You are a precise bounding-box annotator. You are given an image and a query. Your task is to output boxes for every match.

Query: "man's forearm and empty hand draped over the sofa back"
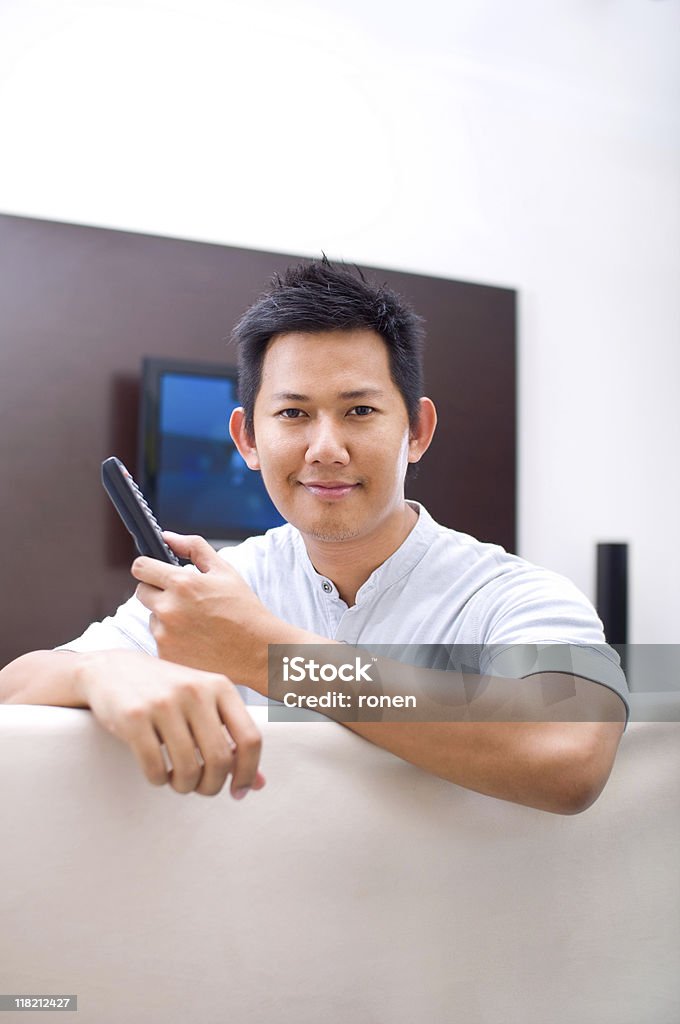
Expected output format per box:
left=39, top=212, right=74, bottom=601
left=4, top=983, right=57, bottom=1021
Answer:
left=0, top=650, right=264, bottom=799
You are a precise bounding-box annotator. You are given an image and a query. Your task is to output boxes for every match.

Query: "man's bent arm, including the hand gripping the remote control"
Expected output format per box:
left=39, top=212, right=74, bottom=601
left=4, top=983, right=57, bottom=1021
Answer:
left=132, top=536, right=625, bottom=814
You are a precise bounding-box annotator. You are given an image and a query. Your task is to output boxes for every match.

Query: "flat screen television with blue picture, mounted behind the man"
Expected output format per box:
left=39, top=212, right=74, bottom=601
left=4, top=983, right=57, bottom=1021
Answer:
left=137, top=357, right=284, bottom=545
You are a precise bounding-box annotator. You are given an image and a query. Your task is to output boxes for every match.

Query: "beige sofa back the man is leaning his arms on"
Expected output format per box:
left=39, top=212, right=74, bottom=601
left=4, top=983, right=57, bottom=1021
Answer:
left=0, top=694, right=680, bottom=1024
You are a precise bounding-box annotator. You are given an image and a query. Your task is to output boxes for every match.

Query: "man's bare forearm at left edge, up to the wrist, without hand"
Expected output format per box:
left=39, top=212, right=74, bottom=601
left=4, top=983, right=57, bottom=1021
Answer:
left=0, top=650, right=88, bottom=708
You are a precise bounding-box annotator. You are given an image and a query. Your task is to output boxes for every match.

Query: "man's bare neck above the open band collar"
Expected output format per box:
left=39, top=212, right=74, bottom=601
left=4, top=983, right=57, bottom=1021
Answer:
left=302, top=502, right=418, bottom=607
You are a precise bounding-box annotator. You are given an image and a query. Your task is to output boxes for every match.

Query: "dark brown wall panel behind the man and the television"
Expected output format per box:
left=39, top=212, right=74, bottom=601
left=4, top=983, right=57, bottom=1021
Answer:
left=0, top=216, right=515, bottom=665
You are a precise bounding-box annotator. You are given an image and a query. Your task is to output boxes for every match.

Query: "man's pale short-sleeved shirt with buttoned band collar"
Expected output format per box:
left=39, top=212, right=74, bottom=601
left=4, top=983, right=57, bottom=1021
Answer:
left=59, top=502, right=629, bottom=720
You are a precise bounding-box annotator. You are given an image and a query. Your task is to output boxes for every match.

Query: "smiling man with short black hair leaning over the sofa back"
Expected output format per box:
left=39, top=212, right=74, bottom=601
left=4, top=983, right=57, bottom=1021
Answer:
left=0, top=259, right=626, bottom=813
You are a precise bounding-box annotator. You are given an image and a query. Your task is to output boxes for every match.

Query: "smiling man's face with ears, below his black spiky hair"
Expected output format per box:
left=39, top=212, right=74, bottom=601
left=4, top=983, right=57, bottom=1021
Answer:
left=235, top=330, right=424, bottom=542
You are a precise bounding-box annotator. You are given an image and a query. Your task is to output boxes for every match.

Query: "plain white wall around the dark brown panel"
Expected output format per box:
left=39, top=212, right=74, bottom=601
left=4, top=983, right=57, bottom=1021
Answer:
left=0, top=0, right=680, bottom=643
